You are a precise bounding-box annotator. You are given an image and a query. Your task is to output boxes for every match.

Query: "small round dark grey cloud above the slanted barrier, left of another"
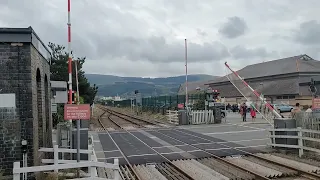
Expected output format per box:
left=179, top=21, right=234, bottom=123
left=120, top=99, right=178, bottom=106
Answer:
left=219, top=16, right=248, bottom=39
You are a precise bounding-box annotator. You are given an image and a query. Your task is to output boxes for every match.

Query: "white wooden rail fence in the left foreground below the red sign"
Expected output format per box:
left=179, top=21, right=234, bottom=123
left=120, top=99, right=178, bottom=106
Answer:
left=13, top=145, right=120, bottom=180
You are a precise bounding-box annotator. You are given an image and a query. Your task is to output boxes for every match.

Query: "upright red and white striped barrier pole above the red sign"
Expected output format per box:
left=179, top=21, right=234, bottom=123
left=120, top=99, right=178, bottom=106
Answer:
left=68, top=0, right=72, bottom=104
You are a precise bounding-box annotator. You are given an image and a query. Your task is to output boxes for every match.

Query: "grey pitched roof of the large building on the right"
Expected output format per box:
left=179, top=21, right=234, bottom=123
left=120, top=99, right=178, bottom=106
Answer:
left=209, top=54, right=320, bottom=84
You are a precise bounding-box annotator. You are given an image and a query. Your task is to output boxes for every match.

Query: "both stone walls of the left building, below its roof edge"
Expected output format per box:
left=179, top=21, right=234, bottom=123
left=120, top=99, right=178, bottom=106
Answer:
left=0, top=43, right=52, bottom=175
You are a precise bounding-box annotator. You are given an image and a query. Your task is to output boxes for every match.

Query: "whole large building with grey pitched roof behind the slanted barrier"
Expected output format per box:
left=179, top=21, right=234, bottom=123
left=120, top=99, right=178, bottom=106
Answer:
left=207, top=54, right=320, bottom=105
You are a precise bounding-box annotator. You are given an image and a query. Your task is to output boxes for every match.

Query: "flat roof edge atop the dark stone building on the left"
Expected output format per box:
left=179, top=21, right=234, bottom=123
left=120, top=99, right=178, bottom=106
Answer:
left=0, top=26, right=51, bottom=61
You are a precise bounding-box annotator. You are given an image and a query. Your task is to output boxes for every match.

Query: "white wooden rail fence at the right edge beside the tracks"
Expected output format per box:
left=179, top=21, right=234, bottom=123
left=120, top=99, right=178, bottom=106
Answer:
left=268, top=127, right=320, bottom=157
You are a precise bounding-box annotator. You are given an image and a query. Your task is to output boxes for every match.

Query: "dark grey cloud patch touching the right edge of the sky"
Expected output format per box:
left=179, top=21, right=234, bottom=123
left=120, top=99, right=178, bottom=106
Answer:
left=294, top=20, right=320, bottom=45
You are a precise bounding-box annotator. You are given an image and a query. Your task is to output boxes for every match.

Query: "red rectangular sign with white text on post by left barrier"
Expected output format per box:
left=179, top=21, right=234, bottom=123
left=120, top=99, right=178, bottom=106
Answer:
left=64, top=104, right=90, bottom=120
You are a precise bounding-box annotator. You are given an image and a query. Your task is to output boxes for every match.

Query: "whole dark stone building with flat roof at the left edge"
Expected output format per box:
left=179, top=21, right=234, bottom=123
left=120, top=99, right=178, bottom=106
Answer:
left=0, top=27, right=52, bottom=175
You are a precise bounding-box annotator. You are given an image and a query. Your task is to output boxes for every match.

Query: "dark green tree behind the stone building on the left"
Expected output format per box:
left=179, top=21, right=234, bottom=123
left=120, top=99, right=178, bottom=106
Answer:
left=48, top=42, right=98, bottom=104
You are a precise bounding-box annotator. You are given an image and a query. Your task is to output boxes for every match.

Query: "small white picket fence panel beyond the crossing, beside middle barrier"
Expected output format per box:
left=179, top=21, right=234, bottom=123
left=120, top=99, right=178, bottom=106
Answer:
left=191, top=110, right=214, bottom=124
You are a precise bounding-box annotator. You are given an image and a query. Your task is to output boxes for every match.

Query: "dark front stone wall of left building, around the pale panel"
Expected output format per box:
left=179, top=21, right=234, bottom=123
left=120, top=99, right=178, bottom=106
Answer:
left=0, top=43, right=33, bottom=174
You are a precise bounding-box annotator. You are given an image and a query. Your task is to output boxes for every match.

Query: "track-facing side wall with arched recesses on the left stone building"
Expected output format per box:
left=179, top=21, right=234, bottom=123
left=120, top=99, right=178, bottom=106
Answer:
left=30, top=45, right=52, bottom=165
